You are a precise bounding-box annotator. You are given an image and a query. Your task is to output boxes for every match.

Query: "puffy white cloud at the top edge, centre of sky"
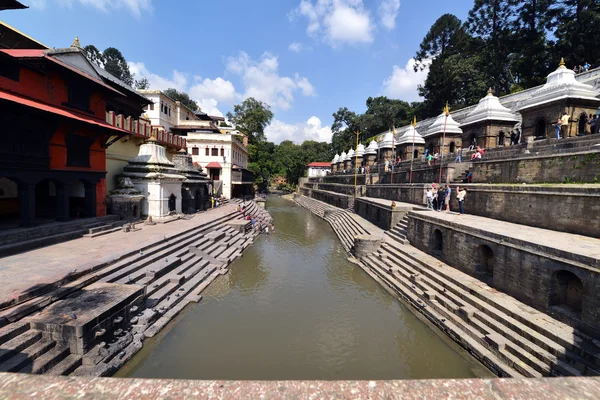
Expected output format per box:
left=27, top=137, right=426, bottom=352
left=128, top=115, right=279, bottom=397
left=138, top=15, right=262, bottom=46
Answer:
left=290, top=0, right=374, bottom=47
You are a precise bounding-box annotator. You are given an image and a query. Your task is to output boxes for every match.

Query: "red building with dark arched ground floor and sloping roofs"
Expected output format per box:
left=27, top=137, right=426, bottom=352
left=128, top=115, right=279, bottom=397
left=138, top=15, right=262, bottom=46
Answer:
left=0, top=47, right=143, bottom=227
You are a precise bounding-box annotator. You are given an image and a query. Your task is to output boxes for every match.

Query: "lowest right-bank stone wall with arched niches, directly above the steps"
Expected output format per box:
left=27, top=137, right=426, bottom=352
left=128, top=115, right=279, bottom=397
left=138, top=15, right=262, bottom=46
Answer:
left=408, top=212, right=600, bottom=334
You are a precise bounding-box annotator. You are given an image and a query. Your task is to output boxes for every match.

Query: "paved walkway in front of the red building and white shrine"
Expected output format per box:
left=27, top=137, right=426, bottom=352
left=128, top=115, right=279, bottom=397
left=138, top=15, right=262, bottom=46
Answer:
left=0, top=204, right=237, bottom=304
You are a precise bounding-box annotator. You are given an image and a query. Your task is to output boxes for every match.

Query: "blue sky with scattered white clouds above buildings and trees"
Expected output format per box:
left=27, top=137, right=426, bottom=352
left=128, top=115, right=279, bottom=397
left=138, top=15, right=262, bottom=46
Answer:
left=0, top=0, right=473, bottom=143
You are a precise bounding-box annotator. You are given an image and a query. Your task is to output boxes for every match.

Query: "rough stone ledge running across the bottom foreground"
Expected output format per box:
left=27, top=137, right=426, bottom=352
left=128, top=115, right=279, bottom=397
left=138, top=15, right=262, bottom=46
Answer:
left=0, top=373, right=600, bottom=400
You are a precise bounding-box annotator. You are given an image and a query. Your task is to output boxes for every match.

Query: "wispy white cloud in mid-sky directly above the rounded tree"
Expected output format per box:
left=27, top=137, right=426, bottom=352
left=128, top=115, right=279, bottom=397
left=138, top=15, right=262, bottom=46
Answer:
left=227, top=52, right=315, bottom=110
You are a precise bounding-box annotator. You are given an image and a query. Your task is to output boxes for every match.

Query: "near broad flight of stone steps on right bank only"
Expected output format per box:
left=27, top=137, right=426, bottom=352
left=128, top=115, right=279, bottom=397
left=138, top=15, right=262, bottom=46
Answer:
left=364, top=238, right=600, bottom=377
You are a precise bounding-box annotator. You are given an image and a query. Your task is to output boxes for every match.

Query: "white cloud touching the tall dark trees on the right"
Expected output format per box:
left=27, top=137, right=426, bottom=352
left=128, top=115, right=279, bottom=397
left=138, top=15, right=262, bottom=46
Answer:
left=382, top=58, right=430, bottom=102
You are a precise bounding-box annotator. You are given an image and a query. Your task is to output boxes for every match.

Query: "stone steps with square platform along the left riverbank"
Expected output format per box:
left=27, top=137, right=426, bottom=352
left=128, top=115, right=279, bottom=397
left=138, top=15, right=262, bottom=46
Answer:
left=0, top=202, right=272, bottom=376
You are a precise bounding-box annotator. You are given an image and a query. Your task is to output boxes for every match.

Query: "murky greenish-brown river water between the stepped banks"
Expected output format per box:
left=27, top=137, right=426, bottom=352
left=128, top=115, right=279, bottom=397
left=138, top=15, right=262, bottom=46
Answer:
left=117, top=196, right=490, bottom=380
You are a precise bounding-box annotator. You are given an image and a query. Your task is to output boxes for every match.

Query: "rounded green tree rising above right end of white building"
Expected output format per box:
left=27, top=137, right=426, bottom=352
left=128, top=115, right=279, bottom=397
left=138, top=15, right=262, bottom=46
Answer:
left=227, top=97, right=273, bottom=143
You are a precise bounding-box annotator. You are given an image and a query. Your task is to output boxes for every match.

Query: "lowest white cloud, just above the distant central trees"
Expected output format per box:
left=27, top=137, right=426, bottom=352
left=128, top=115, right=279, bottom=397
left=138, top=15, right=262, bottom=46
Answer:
left=265, top=116, right=332, bottom=144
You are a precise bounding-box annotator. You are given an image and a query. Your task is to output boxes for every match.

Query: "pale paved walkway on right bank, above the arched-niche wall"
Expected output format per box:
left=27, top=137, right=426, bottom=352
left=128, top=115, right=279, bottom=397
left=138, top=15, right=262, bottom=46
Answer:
left=410, top=211, right=600, bottom=259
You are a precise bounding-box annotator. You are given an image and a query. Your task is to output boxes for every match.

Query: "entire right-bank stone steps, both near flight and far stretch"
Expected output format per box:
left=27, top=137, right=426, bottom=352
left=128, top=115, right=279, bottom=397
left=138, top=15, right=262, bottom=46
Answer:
left=295, top=196, right=600, bottom=377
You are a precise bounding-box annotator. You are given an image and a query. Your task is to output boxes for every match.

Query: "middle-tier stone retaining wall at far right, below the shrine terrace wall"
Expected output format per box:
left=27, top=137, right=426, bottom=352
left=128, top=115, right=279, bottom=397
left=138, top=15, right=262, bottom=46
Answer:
left=471, top=150, right=600, bottom=183
